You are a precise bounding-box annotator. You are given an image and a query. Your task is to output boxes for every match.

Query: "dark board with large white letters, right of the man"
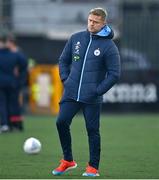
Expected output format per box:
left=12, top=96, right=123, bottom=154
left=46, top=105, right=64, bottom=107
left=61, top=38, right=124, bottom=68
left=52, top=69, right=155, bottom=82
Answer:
left=103, top=70, right=159, bottom=112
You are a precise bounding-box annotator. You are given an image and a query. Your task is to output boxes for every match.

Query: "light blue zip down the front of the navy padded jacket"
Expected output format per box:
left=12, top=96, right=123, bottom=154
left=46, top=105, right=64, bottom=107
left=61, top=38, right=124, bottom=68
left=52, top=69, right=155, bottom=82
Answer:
left=77, top=35, right=92, bottom=101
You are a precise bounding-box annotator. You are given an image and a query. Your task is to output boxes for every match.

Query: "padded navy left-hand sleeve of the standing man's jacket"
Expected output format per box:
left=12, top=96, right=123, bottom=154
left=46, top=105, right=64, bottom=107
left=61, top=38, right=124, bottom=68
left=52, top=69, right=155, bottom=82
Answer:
left=59, top=37, right=72, bottom=82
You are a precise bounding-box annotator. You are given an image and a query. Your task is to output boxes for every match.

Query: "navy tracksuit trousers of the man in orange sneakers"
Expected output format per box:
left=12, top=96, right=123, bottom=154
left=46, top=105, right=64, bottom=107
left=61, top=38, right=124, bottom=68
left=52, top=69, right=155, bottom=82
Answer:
left=56, top=100, right=101, bottom=169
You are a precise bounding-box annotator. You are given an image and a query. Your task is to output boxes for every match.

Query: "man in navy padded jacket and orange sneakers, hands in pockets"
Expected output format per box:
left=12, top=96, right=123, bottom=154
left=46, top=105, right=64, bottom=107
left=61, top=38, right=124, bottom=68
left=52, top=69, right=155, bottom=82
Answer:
left=52, top=8, right=120, bottom=177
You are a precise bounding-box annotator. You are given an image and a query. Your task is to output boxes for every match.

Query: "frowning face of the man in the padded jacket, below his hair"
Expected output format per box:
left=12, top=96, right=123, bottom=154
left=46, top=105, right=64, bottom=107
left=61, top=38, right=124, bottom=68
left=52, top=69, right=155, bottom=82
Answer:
left=88, top=14, right=106, bottom=33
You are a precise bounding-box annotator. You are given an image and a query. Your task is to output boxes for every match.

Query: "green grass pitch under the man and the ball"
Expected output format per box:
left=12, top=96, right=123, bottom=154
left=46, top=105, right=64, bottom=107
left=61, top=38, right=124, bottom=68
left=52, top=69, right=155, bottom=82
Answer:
left=0, top=114, right=159, bottom=179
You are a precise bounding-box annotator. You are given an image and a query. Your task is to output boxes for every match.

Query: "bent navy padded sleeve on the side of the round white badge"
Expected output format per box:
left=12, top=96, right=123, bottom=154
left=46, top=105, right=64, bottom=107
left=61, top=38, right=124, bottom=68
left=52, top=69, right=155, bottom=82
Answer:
left=97, top=43, right=121, bottom=95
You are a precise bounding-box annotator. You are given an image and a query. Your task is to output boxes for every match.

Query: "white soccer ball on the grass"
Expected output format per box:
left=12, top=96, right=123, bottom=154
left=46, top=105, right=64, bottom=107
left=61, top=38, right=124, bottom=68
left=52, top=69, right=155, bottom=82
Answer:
left=23, top=137, right=41, bottom=154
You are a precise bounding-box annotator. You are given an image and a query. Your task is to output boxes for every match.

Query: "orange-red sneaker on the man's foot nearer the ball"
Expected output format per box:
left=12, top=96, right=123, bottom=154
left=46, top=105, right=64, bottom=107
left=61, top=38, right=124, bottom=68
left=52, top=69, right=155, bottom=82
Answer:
left=52, top=159, right=77, bottom=176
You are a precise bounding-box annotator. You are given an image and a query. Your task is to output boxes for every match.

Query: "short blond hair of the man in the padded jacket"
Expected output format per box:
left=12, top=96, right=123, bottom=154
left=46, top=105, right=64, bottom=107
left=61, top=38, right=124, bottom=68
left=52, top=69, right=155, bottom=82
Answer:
left=89, top=7, right=108, bottom=21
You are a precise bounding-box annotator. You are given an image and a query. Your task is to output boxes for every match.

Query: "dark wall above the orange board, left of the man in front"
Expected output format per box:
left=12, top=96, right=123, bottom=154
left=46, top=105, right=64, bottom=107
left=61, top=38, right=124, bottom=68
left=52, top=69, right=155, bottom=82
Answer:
left=17, top=35, right=66, bottom=64
